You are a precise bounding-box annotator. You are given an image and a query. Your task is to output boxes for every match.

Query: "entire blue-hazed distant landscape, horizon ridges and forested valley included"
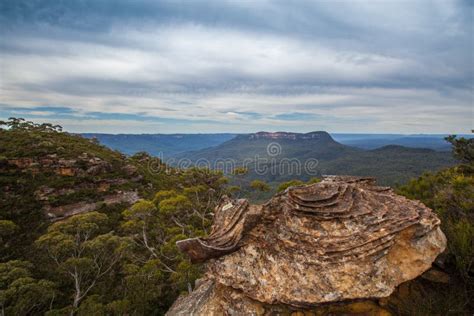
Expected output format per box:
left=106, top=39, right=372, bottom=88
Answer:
left=82, top=131, right=462, bottom=185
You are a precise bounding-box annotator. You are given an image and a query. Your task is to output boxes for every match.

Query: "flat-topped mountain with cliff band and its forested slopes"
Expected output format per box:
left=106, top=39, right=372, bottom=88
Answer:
left=176, top=131, right=454, bottom=185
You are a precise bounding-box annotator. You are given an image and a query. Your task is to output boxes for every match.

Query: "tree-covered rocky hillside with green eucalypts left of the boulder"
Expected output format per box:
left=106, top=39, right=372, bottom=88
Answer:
left=0, top=119, right=227, bottom=315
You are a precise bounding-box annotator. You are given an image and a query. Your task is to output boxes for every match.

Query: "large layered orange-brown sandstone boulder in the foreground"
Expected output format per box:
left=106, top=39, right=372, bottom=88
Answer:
left=168, top=177, right=446, bottom=315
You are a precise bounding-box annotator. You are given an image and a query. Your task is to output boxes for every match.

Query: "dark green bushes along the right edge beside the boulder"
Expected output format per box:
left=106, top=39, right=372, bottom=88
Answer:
left=398, top=136, right=474, bottom=314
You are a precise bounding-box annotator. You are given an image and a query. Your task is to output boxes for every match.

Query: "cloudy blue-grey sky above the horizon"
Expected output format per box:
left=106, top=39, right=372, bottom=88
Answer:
left=0, top=0, right=474, bottom=133
